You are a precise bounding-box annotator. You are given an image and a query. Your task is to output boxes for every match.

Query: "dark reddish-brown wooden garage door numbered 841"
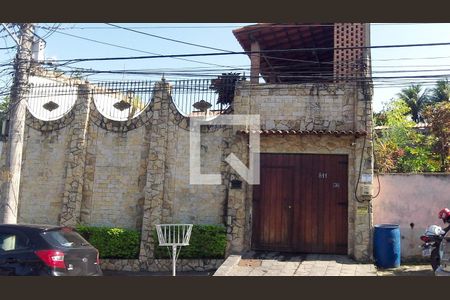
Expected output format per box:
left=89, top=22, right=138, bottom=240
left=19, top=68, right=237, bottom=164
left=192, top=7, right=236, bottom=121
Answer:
left=252, top=154, right=348, bottom=254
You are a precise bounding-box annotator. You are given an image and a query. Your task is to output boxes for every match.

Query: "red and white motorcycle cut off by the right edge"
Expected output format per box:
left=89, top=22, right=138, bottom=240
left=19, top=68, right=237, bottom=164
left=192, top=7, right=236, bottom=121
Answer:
left=420, top=225, right=450, bottom=271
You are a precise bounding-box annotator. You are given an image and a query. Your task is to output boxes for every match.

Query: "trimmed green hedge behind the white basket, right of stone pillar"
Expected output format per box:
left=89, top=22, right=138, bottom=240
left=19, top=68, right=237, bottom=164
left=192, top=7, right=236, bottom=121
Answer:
left=153, top=225, right=227, bottom=259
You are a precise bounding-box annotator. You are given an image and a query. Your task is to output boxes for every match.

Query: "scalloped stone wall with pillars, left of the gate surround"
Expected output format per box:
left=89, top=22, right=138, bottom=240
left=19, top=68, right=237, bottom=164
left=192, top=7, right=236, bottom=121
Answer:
left=9, top=82, right=230, bottom=271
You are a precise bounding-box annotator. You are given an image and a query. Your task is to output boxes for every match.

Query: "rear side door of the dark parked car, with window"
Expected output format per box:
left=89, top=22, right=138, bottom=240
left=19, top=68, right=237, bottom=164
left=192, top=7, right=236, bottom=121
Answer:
left=0, top=229, right=36, bottom=276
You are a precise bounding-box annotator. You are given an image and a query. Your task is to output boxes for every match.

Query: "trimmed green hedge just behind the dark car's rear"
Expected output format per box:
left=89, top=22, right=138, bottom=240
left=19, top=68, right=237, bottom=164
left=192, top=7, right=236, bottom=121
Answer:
left=76, top=226, right=140, bottom=259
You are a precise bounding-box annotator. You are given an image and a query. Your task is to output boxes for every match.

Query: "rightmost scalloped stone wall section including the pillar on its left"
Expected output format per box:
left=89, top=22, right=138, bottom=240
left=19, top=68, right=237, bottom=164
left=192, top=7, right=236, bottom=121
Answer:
left=139, top=83, right=229, bottom=269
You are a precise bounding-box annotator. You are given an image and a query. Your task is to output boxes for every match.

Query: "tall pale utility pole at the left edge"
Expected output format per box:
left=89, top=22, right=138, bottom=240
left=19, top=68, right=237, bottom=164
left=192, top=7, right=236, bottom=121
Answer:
left=0, top=23, right=34, bottom=224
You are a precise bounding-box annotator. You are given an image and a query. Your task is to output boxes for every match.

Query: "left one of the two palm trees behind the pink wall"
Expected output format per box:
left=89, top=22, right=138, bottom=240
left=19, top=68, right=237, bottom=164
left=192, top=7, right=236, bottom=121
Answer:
left=397, top=84, right=429, bottom=123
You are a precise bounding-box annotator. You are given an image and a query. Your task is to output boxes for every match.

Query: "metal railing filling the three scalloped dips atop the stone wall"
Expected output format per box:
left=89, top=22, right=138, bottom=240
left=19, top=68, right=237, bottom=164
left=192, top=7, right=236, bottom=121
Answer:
left=23, top=79, right=239, bottom=121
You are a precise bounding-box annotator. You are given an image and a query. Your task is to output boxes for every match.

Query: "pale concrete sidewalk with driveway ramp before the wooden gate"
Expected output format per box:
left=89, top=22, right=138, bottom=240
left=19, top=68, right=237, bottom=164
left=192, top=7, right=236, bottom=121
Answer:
left=104, top=252, right=434, bottom=276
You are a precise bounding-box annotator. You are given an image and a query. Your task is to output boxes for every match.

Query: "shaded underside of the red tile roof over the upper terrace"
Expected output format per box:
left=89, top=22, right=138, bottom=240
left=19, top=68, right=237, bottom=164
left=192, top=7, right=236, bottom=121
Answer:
left=233, top=23, right=334, bottom=83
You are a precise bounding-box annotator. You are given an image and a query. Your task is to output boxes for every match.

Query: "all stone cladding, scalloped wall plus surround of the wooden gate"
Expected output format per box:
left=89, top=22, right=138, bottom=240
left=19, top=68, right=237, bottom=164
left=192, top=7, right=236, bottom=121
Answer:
left=8, top=74, right=373, bottom=270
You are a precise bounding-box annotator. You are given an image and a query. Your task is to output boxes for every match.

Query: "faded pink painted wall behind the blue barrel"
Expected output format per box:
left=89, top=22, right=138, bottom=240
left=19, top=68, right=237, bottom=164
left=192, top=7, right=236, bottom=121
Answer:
left=373, top=174, right=450, bottom=258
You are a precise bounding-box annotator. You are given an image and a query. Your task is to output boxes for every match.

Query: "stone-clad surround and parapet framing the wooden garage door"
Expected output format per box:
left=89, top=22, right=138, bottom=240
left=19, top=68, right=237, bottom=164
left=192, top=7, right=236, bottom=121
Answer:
left=230, top=83, right=373, bottom=260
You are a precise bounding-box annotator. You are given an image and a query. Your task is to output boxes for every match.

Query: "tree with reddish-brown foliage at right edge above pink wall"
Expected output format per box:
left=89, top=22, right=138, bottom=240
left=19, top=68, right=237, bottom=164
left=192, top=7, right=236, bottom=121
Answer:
left=424, top=101, right=450, bottom=172
